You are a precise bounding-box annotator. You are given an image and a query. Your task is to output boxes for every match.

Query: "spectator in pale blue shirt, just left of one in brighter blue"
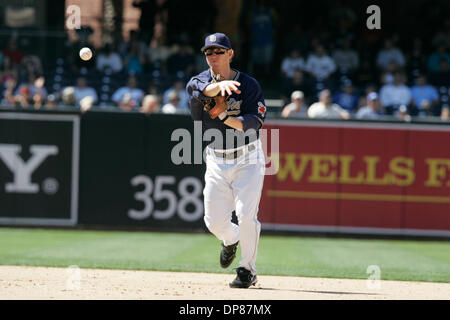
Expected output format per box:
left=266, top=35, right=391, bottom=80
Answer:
left=380, top=72, right=411, bottom=115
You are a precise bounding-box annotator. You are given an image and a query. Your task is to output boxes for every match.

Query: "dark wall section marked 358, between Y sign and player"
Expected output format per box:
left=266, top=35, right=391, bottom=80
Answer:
left=80, top=112, right=205, bottom=228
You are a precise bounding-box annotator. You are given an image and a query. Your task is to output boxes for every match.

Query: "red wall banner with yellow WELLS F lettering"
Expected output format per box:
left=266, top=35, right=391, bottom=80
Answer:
left=259, top=121, right=450, bottom=235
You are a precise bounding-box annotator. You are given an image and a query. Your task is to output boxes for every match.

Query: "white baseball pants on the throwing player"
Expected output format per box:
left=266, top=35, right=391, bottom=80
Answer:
left=203, top=140, right=265, bottom=274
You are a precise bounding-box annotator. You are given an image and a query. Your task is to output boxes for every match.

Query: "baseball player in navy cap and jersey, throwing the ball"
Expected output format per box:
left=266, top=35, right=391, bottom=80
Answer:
left=186, top=33, right=266, bottom=288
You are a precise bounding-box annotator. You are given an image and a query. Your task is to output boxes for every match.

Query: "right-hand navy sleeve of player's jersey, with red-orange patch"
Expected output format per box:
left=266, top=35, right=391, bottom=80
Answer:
left=238, top=78, right=267, bottom=131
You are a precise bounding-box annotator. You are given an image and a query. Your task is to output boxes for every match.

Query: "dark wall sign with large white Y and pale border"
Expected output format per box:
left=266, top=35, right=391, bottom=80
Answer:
left=0, top=112, right=79, bottom=226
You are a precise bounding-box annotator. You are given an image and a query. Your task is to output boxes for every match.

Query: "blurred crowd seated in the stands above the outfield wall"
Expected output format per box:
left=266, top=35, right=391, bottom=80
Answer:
left=0, top=1, right=450, bottom=120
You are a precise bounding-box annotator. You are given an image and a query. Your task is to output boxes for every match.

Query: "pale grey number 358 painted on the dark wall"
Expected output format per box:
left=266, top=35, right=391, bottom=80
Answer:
left=128, top=175, right=203, bottom=222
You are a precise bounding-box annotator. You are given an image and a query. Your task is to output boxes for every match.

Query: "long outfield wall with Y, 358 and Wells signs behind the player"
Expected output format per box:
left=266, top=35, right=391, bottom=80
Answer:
left=0, top=111, right=450, bottom=237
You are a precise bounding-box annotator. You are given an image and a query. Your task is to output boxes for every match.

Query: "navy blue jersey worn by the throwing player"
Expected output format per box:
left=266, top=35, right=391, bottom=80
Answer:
left=186, top=69, right=266, bottom=149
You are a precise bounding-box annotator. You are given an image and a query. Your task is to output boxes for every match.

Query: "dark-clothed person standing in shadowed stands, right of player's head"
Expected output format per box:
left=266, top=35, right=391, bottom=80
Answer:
left=248, top=0, right=277, bottom=74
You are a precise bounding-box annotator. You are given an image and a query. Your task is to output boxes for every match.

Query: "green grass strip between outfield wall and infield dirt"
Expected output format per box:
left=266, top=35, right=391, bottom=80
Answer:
left=0, top=228, right=450, bottom=282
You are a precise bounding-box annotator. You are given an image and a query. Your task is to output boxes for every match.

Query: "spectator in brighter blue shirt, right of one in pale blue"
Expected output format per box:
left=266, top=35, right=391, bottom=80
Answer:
left=411, top=74, right=439, bottom=116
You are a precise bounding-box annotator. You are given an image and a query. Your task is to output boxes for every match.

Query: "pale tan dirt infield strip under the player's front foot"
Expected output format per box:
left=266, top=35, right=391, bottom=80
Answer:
left=0, top=266, right=450, bottom=300
